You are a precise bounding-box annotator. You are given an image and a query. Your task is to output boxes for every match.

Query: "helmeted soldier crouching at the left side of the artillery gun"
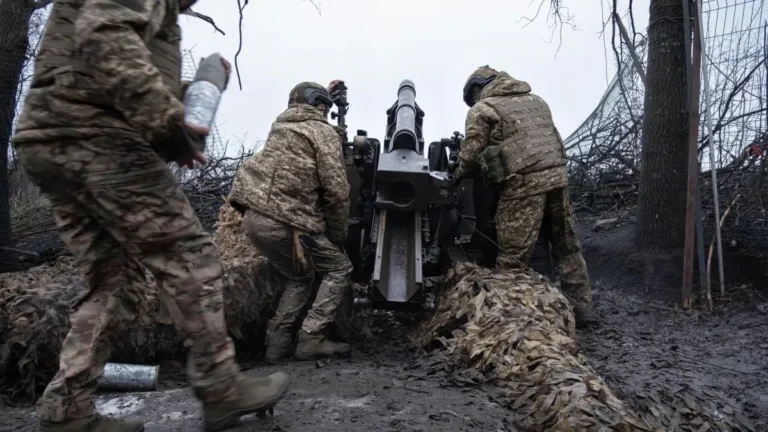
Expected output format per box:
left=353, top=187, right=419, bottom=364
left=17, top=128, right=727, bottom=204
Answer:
left=229, top=82, right=352, bottom=363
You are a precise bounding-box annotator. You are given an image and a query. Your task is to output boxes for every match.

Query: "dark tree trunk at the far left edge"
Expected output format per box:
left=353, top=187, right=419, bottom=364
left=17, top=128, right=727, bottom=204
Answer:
left=0, top=0, right=35, bottom=271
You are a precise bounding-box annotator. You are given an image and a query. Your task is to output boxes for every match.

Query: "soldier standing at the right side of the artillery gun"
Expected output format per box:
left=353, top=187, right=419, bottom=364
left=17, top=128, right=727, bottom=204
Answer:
left=456, top=66, right=592, bottom=324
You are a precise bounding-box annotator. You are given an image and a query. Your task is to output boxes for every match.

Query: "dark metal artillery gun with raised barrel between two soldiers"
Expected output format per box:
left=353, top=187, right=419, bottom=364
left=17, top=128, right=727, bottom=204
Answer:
left=332, top=80, right=552, bottom=310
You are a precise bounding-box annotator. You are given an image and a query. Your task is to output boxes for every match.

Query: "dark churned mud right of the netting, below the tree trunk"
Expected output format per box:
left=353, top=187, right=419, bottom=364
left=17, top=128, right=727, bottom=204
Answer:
left=579, top=221, right=768, bottom=431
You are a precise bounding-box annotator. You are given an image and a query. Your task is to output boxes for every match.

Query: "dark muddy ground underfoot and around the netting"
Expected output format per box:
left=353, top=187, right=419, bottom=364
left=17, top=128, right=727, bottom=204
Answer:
left=0, top=216, right=768, bottom=432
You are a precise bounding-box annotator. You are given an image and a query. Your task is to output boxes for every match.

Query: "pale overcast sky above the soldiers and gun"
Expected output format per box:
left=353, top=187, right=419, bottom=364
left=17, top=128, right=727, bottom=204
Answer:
left=182, top=0, right=648, bottom=151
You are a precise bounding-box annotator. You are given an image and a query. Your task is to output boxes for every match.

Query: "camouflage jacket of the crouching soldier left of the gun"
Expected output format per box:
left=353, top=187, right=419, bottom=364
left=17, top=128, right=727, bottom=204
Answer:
left=229, top=105, right=349, bottom=243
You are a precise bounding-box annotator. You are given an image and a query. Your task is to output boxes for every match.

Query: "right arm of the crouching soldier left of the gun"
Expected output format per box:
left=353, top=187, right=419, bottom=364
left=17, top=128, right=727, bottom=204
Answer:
left=315, top=127, right=349, bottom=244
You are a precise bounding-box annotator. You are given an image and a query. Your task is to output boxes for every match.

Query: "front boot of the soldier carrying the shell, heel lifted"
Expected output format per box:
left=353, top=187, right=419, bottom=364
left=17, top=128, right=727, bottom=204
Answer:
left=203, top=372, right=290, bottom=432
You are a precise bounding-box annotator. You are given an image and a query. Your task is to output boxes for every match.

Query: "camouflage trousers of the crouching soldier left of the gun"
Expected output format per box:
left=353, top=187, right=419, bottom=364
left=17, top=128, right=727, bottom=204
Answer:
left=245, top=210, right=352, bottom=340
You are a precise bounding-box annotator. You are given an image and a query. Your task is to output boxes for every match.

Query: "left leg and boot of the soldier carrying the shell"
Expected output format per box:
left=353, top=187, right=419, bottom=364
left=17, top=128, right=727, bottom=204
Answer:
left=17, top=142, right=146, bottom=432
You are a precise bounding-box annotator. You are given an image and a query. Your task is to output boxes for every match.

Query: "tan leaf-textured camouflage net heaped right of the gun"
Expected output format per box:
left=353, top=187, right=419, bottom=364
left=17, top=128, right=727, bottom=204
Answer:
left=416, top=264, right=662, bottom=432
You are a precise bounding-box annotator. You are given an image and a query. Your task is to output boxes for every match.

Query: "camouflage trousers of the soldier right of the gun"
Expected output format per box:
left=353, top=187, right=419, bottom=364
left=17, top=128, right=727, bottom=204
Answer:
left=496, top=188, right=592, bottom=308
